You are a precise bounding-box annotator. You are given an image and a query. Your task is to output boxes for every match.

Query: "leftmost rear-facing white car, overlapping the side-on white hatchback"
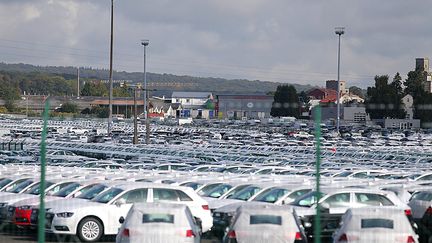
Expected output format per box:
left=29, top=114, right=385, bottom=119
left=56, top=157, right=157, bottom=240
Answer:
left=116, top=203, right=201, bottom=243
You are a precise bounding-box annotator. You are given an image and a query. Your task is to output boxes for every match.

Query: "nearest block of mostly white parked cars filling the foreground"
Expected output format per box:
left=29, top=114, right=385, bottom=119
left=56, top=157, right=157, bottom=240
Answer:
left=0, top=165, right=432, bottom=242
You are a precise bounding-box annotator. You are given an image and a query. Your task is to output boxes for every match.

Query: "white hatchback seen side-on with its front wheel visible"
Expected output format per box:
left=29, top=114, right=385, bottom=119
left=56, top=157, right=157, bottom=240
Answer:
left=47, top=183, right=213, bottom=242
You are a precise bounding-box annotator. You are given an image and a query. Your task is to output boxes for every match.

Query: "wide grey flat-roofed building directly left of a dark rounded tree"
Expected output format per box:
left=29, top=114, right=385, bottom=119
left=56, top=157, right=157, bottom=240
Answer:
left=216, top=94, right=273, bottom=119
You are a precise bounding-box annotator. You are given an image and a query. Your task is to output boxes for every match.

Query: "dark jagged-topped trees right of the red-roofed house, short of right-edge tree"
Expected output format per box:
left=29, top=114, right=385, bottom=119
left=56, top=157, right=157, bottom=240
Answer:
left=366, top=74, right=405, bottom=119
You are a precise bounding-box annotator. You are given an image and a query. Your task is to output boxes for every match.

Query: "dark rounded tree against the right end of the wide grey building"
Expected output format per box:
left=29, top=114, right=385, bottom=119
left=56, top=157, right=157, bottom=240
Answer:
left=270, top=85, right=300, bottom=118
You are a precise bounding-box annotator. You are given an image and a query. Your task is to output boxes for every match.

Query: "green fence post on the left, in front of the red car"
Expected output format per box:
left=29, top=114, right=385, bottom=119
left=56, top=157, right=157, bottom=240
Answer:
left=38, top=99, right=49, bottom=243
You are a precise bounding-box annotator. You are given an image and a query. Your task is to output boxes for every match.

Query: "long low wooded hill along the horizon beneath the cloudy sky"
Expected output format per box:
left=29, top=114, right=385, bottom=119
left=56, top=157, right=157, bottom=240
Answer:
left=0, top=63, right=313, bottom=94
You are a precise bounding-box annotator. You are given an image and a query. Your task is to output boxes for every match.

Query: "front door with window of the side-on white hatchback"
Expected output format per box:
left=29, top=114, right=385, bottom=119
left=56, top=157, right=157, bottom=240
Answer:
left=105, top=188, right=148, bottom=233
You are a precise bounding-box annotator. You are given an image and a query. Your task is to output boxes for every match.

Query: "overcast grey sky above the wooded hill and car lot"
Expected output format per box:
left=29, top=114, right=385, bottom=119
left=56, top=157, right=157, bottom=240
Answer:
left=0, top=0, right=432, bottom=87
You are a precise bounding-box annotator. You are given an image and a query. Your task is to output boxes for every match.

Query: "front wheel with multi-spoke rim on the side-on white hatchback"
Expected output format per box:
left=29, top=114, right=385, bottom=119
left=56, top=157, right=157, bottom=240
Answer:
left=77, top=217, right=103, bottom=242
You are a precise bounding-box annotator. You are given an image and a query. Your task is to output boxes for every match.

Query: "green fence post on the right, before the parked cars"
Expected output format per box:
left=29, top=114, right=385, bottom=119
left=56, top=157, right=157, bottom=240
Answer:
left=314, top=105, right=321, bottom=243
